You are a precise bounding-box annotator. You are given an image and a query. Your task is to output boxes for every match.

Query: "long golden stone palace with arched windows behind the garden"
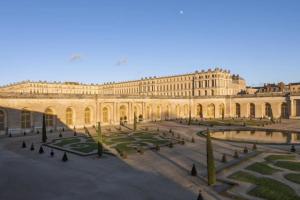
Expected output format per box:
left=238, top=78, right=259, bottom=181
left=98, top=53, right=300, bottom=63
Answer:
left=0, top=68, right=300, bottom=133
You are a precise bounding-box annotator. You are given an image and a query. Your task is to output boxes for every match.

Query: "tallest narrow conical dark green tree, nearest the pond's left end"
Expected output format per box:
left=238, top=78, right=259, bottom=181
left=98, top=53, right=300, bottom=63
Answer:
left=206, top=130, right=216, bottom=185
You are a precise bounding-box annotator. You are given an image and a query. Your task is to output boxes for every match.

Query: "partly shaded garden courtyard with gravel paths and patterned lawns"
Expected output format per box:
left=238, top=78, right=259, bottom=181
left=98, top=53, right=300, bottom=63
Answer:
left=0, top=120, right=300, bottom=200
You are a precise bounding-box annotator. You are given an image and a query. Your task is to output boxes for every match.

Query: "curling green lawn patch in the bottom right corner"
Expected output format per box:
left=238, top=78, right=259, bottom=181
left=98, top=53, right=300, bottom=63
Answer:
left=229, top=171, right=300, bottom=200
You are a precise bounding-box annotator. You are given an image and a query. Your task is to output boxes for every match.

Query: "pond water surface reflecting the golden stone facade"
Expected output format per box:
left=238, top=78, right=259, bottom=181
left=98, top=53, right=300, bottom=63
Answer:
left=211, top=130, right=300, bottom=144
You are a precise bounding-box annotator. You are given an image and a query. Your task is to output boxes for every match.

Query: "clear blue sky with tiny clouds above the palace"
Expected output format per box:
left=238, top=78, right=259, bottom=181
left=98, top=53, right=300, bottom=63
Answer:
left=0, top=0, right=300, bottom=85
